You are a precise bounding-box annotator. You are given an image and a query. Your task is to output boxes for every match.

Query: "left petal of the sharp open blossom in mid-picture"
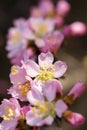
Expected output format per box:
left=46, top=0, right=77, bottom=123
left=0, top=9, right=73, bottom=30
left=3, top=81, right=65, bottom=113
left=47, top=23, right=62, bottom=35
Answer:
left=22, top=60, right=39, bottom=78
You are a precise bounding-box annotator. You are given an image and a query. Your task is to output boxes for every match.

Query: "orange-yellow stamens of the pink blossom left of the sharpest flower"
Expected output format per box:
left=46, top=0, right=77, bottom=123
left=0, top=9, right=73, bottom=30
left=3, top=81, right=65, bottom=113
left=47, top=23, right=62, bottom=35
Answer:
left=18, top=81, right=31, bottom=96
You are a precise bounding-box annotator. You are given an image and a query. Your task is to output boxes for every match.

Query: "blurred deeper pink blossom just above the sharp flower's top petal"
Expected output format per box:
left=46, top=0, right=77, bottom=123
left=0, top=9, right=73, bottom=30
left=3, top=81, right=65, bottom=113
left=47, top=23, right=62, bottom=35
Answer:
left=41, top=31, right=64, bottom=53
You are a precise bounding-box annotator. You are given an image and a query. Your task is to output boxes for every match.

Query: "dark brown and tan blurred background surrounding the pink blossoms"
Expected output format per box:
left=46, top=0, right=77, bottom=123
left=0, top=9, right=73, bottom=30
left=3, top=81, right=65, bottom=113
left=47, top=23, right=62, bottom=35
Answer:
left=0, top=0, right=87, bottom=130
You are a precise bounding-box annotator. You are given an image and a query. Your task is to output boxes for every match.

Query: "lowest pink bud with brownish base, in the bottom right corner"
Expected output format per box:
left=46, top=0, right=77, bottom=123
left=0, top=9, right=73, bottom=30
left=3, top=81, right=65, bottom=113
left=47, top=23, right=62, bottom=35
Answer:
left=64, top=111, right=85, bottom=126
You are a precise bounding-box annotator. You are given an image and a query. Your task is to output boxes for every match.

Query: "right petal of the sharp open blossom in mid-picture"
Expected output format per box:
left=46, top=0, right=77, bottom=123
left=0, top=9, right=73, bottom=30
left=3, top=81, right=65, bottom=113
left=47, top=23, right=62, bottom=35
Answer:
left=53, top=61, right=67, bottom=78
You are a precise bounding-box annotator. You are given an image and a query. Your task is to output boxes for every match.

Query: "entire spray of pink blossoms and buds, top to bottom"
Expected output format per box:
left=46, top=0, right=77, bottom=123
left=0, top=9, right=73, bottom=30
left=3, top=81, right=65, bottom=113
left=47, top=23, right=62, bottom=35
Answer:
left=0, top=0, right=87, bottom=130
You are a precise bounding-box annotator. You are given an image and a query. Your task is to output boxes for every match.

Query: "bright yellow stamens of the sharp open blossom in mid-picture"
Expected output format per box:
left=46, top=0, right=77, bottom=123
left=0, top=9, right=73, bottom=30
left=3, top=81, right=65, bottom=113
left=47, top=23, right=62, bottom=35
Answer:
left=37, top=68, right=54, bottom=81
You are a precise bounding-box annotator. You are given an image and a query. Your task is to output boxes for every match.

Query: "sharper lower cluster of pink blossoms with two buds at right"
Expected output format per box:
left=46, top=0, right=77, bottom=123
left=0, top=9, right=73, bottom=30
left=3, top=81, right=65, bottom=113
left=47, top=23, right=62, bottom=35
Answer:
left=0, top=52, right=85, bottom=130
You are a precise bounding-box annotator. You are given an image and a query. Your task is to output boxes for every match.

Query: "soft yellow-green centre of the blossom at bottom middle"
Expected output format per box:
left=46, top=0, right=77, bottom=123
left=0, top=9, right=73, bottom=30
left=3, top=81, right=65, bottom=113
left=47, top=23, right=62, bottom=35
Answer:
left=32, top=100, right=55, bottom=118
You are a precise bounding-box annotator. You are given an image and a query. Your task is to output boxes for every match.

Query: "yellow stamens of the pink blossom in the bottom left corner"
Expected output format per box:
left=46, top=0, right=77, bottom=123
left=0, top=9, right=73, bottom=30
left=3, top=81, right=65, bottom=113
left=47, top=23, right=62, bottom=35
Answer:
left=2, top=107, right=14, bottom=121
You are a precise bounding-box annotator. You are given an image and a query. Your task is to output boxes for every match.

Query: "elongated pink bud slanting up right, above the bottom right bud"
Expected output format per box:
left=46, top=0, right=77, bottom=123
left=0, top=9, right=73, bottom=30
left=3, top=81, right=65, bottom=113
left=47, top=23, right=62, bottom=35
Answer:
left=68, top=82, right=85, bottom=99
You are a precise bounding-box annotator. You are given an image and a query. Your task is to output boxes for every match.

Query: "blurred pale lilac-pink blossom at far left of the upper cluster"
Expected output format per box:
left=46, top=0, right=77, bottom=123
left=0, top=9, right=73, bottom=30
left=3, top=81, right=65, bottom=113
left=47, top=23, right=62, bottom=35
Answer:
left=6, top=19, right=35, bottom=65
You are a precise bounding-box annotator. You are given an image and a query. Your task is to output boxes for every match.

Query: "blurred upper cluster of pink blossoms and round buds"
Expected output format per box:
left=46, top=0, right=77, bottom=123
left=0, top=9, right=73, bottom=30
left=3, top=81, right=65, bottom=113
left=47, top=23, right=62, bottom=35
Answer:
left=6, top=0, right=87, bottom=65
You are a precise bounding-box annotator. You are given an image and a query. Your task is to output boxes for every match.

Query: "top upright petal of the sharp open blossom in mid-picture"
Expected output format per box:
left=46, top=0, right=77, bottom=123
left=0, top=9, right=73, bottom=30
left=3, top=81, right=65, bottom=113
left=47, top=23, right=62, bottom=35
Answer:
left=38, top=52, right=54, bottom=69
